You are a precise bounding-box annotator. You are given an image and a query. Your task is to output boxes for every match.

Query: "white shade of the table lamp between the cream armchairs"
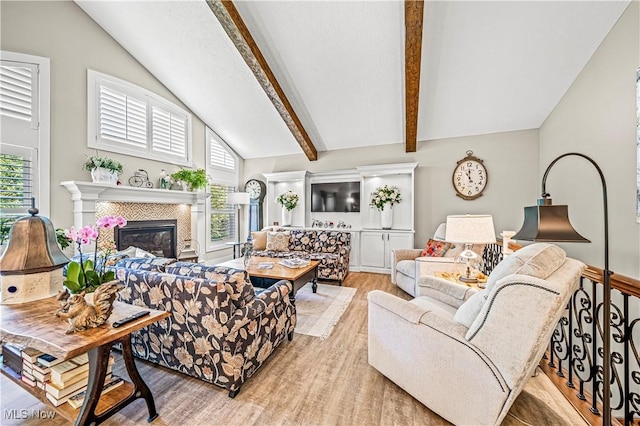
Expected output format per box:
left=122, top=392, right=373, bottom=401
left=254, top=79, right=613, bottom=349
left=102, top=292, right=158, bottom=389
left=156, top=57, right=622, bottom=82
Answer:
left=445, top=214, right=496, bottom=244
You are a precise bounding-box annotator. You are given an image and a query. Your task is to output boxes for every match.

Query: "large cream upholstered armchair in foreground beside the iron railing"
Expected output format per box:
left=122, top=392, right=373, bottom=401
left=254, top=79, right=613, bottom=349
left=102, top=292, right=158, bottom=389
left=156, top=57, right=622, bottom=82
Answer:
left=369, top=243, right=584, bottom=425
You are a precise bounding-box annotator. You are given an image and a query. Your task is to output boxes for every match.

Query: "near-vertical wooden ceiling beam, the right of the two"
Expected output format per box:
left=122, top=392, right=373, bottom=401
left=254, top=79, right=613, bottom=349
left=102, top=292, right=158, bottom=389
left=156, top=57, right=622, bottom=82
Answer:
left=404, top=0, right=424, bottom=152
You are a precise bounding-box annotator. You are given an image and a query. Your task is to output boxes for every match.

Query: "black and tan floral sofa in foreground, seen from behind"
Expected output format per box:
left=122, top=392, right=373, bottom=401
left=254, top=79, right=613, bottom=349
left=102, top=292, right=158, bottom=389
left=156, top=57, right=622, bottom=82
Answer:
left=115, top=258, right=296, bottom=398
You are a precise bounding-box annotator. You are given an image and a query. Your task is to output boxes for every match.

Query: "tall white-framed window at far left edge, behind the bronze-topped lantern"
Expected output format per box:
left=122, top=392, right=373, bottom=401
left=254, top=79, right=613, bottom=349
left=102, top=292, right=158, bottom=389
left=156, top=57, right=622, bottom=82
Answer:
left=0, top=52, right=50, bottom=244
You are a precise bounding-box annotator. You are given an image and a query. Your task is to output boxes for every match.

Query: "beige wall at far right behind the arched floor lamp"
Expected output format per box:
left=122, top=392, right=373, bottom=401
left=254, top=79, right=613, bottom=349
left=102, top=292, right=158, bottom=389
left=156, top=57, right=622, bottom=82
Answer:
left=539, top=1, right=640, bottom=278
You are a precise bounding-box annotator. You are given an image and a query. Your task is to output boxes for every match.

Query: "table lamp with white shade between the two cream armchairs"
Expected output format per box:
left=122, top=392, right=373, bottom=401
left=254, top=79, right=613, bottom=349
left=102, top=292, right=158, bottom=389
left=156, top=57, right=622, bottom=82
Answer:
left=444, top=214, right=496, bottom=283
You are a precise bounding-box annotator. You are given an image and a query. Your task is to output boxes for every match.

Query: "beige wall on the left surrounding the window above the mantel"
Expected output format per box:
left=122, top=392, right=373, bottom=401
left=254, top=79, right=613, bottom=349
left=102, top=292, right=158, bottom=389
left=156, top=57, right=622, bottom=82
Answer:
left=0, top=1, right=205, bottom=233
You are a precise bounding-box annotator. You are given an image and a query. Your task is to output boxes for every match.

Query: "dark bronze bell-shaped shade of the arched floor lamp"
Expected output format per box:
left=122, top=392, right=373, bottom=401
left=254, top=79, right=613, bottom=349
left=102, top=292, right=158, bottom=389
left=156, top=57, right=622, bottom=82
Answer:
left=511, top=205, right=591, bottom=243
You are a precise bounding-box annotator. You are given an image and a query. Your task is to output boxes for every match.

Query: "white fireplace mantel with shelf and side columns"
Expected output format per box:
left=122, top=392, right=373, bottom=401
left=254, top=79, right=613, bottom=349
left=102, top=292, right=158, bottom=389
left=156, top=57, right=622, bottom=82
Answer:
left=60, top=181, right=210, bottom=248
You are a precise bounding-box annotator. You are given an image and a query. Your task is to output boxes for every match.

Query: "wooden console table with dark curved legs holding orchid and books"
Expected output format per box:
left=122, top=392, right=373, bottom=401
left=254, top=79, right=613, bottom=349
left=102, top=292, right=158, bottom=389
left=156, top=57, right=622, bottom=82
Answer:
left=0, top=297, right=170, bottom=425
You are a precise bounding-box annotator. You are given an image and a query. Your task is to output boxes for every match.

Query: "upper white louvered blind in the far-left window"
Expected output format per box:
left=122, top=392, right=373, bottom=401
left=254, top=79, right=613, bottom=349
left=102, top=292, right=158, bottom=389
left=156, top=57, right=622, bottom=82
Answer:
left=0, top=61, right=38, bottom=125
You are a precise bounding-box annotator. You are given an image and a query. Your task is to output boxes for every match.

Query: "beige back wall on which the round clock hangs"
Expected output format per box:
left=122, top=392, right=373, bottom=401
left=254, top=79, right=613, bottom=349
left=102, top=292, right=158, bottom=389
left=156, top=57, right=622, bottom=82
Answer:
left=244, top=130, right=540, bottom=247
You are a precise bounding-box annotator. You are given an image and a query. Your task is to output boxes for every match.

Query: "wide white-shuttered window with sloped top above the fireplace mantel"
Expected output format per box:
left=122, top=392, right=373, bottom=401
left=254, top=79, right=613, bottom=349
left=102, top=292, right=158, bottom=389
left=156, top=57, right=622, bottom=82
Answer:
left=87, top=70, right=191, bottom=166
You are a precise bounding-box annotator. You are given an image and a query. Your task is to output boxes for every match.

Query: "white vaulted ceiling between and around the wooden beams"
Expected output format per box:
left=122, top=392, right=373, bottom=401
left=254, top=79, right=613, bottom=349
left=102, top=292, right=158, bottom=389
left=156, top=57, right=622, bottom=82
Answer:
left=76, top=0, right=629, bottom=158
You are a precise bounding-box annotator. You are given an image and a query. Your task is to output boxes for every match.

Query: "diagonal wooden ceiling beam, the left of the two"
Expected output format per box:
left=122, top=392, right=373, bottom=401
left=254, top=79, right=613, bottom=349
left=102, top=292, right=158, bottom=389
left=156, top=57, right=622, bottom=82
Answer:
left=207, top=0, right=318, bottom=161
